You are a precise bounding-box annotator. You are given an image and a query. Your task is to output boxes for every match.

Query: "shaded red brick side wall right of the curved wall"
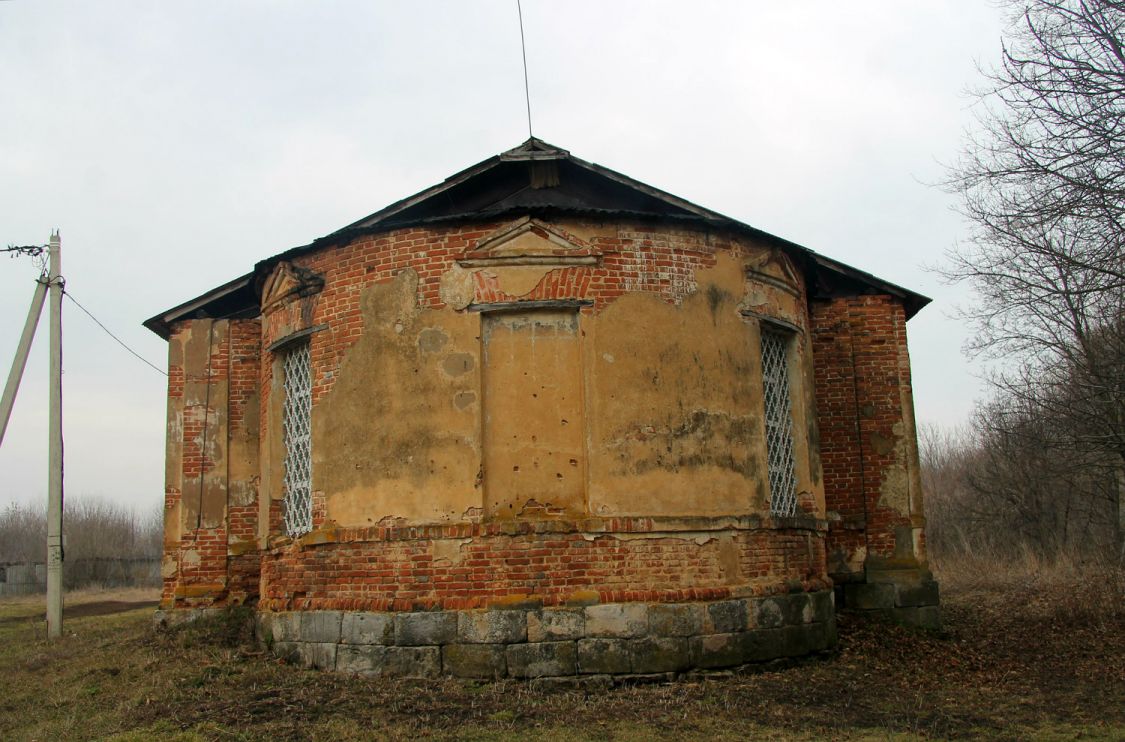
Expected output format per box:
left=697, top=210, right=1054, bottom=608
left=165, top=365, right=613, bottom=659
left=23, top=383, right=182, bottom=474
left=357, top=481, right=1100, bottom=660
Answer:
left=811, top=296, right=924, bottom=578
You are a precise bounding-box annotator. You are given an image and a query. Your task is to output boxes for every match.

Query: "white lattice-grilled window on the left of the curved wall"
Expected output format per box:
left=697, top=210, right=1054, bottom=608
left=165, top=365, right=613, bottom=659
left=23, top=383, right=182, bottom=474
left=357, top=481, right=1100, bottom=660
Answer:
left=281, top=341, right=313, bottom=536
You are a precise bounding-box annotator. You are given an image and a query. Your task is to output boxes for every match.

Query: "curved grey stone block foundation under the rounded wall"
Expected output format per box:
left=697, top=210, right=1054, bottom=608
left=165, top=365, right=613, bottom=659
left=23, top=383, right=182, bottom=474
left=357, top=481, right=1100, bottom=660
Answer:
left=258, top=590, right=836, bottom=680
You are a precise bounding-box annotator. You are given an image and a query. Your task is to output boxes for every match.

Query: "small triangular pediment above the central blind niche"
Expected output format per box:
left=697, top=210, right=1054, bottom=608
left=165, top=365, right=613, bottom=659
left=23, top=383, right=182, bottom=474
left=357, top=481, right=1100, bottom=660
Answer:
left=458, top=217, right=601, bottom=268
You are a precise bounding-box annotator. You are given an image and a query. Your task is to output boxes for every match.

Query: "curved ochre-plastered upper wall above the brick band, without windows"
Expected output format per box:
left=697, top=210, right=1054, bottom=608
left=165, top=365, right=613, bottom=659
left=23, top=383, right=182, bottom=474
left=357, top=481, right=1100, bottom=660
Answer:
left=253, top=215, right=822, bottom=537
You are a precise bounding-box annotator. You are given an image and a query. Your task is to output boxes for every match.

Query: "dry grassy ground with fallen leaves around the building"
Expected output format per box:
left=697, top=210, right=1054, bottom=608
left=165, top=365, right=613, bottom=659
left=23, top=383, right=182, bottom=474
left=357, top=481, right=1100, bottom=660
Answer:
left=0, top=564, right=1125, bottom=742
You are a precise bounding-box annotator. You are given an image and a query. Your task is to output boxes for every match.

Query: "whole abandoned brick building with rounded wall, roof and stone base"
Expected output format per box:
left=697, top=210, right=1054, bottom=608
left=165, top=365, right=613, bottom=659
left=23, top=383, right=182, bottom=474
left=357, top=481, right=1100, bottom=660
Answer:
left=145, top=138, right=938, bottom=678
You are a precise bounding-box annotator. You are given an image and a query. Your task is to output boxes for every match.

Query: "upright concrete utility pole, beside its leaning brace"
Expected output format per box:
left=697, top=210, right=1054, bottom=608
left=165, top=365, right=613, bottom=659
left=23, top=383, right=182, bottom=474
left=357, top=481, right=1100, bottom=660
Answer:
left=47, top=232, right=63, bottom=639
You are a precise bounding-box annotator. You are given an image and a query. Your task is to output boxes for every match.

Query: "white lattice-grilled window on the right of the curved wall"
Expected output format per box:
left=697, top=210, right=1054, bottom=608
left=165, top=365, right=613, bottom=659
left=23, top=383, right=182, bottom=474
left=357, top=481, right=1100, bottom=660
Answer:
left=762, top=326, right=797, bottom=515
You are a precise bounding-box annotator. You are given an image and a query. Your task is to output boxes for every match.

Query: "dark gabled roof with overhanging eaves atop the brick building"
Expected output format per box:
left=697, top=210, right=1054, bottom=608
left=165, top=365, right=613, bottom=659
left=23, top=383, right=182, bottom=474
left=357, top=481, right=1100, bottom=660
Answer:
left=144, top=138, right=929, bottom=338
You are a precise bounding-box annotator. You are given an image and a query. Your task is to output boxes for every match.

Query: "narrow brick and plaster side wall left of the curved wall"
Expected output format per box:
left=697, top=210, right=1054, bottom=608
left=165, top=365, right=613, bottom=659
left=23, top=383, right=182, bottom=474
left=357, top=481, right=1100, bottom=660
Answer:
left=161, top=319, right=261, bottom=607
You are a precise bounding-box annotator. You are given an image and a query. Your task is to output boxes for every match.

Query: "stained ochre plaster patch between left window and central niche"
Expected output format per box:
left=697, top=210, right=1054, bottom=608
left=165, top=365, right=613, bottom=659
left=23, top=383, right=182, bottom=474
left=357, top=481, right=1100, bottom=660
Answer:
left=313, top=270, right=480, bottom=525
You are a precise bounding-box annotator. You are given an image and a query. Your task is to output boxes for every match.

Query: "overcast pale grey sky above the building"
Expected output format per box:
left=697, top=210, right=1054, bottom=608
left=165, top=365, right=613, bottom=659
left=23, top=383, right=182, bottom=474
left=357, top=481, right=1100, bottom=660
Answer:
left=0, top=0, right=1001, bottom=509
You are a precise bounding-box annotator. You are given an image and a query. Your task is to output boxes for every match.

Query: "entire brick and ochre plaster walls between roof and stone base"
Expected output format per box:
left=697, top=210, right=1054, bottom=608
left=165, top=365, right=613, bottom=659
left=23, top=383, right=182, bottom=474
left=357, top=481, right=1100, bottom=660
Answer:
left=164, top=214, right=923, bottom=610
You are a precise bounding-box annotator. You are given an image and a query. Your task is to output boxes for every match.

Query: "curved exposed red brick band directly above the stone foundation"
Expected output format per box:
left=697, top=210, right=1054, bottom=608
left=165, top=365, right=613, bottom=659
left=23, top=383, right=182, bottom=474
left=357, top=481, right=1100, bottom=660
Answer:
left=260, top=518, right=829, bottom=610
